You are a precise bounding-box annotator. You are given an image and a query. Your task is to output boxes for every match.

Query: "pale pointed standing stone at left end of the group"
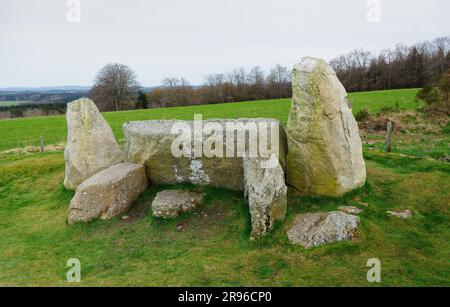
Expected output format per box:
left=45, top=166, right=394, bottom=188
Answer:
left=64, top=98, right=123, bottom=190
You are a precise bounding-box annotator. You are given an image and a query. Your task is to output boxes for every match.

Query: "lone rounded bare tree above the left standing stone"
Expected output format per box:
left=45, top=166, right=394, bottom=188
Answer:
left=94, top=63, right=139, bottom=111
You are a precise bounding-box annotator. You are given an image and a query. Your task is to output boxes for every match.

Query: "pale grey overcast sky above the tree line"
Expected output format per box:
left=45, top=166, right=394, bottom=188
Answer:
left=0, top=0, right=450, bottom=87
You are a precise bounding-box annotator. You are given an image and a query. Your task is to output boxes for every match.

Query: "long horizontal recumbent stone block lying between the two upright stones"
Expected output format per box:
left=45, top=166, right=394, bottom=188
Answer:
left=123, top=119, right=287, bottom=191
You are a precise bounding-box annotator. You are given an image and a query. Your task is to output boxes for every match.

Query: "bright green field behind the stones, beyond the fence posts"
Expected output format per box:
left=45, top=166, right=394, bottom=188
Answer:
left=0, top=89, right=419, bottom=151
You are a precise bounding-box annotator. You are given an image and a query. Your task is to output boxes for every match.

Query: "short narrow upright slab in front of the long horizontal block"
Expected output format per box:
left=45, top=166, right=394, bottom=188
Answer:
left=243, top=158, right=287, bottom=239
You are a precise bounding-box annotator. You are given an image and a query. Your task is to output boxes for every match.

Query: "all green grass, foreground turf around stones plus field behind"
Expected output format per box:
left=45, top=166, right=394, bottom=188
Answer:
left=0, top=90, right=450, bottom=286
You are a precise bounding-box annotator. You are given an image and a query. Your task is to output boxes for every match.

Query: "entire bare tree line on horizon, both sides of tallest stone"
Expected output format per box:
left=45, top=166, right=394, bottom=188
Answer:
left=90, top=37, right=450, bottom=111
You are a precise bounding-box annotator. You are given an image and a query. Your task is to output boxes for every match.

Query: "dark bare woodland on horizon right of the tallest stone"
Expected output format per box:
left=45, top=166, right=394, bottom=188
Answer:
left=330, top=37, right=450, bottom=92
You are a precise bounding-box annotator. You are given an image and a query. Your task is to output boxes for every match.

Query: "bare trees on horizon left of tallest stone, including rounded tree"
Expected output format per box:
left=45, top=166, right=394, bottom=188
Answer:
left=89, top=64, right=292, bottom=111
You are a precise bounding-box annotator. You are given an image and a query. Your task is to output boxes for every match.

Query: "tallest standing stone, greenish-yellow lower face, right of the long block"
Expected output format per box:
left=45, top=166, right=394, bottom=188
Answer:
left=286, top=58, right=366, bottom=196
